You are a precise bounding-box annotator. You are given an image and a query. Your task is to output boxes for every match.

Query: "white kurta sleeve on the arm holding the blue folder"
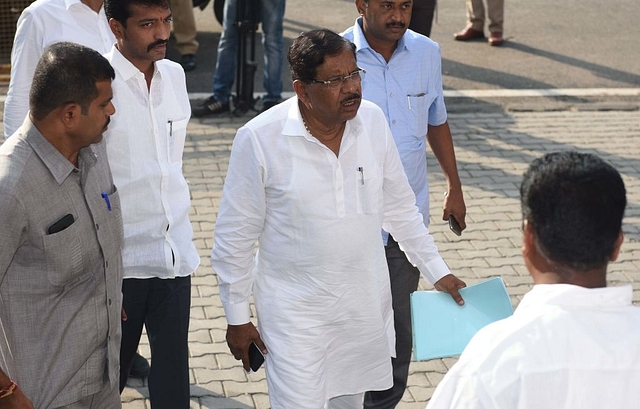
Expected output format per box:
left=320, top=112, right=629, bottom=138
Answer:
left=382, top=121, right=451, bottom=284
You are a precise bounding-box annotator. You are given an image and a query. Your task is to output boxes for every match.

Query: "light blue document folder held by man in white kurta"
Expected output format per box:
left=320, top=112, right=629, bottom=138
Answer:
left=411, top=277, right=513, bottom=361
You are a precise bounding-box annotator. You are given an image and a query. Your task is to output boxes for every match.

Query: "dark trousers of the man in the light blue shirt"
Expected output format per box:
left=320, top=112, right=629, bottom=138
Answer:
left=364, top=236, right=420, bottom=409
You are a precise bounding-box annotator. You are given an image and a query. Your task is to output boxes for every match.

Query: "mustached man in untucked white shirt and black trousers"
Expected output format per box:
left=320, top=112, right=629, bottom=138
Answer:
left=104, top=0, right=200, bottom=409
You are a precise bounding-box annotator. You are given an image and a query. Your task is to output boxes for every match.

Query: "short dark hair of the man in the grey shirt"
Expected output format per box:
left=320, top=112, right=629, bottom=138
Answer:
left=29, top=42, right=116, bottom=120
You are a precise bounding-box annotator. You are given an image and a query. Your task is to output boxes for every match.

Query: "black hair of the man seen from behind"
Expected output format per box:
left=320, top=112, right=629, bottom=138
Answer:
left=520, top=151, right=627, bottom=272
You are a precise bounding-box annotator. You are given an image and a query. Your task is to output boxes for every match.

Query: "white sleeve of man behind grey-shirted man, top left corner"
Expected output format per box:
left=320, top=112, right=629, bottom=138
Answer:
left=3, top=12, right=43, bottom=138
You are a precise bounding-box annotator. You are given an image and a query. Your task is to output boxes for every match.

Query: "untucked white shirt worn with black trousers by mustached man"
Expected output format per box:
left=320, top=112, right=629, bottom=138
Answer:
left=104, top=46, right=200, bottom=278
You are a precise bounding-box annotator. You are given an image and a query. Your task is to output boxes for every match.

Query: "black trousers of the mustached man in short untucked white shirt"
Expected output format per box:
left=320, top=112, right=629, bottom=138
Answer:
left=120, top=276, right=191, bottom=409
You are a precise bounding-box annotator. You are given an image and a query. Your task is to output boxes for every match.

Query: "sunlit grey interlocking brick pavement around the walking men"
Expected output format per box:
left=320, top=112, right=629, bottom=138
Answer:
left=117, top=107, right=640, bottom=409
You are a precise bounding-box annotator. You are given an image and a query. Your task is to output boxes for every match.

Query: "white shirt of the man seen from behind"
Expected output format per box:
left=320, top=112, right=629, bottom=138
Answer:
left=427, top=284, right=640, bottom=409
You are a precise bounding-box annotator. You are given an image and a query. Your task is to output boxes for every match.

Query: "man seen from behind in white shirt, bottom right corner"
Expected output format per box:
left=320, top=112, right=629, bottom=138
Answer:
left=427, top=151, right=640, bottom=409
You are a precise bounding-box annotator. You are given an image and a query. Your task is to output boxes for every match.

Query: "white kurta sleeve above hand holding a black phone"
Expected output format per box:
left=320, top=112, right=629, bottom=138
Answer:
left=211, top=127, right=266, bottom=325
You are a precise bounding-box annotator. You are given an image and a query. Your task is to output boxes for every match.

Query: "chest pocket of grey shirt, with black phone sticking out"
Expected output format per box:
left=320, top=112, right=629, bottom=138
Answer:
left=42, top=220, right=85, bottom=286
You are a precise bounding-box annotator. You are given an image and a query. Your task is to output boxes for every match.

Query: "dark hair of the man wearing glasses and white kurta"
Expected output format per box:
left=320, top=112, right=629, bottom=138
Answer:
left=287, top=29, right=356, bottom=82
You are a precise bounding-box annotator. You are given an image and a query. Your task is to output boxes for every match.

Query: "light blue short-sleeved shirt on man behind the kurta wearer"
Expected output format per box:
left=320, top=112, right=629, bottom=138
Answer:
left=342, top=17, right=447, bottom=242
